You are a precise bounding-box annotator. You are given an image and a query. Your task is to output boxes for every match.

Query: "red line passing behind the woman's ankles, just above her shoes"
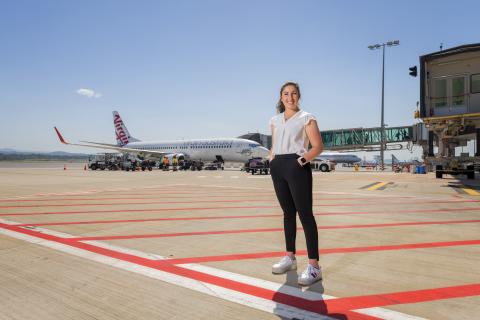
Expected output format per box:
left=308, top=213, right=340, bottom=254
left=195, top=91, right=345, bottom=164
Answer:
left=169, top=240, right=480, bottom=264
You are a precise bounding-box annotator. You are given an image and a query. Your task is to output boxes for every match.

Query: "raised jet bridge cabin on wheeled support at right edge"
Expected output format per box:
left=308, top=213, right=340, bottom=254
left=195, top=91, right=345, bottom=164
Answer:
left=410, top=43, right=480, bottom=179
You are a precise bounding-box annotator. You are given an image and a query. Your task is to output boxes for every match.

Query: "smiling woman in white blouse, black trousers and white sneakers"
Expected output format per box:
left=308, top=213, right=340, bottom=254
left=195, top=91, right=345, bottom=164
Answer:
left=270, top=82, right=323, bottom=285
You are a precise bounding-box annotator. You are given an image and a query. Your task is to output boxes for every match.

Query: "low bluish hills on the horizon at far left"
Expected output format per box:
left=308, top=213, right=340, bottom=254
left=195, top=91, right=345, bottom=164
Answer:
left=0, top=148, right=88, bottom=161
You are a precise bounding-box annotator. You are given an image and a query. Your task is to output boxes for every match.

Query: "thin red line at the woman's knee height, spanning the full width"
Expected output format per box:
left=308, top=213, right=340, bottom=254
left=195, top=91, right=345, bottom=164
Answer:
left=0, top=206, right=480, bottom=217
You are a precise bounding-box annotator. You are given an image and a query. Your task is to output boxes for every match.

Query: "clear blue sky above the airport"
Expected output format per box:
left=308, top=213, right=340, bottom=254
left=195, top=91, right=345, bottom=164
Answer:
left=0, top=0, right=480, bottom=159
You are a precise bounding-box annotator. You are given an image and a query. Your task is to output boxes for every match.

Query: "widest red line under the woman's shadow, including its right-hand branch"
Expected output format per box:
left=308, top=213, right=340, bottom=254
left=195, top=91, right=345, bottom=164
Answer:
left=0, top=224, right=480, bottom=320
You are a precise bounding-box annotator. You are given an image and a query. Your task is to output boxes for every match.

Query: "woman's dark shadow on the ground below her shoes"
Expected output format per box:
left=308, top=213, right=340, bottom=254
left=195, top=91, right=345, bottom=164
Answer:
left=272, top=270, right=348, bottom=320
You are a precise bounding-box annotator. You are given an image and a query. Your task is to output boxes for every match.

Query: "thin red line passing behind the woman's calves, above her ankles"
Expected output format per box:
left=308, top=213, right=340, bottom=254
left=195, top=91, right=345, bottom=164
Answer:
left=73, top=220, right=480, bottom=241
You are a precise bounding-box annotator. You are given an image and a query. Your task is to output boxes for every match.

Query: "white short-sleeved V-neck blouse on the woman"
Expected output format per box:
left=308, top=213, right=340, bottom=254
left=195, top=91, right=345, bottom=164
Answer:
left=270, top=110, right=317, bottom=155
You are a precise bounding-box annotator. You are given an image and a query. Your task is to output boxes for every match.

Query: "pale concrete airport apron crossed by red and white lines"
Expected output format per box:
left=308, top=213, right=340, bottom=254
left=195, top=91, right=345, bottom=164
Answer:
left=0, top=163, right=480, bottom=320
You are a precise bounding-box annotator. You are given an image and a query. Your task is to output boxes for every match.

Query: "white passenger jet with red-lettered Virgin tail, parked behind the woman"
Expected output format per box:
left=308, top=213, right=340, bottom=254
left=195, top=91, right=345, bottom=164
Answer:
left=54, top=111, right=268, bottom=163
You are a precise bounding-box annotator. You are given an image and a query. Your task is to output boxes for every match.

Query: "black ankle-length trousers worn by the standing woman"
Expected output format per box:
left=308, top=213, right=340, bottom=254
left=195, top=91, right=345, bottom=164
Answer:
left=270, top=153, right=318, bottom=260
